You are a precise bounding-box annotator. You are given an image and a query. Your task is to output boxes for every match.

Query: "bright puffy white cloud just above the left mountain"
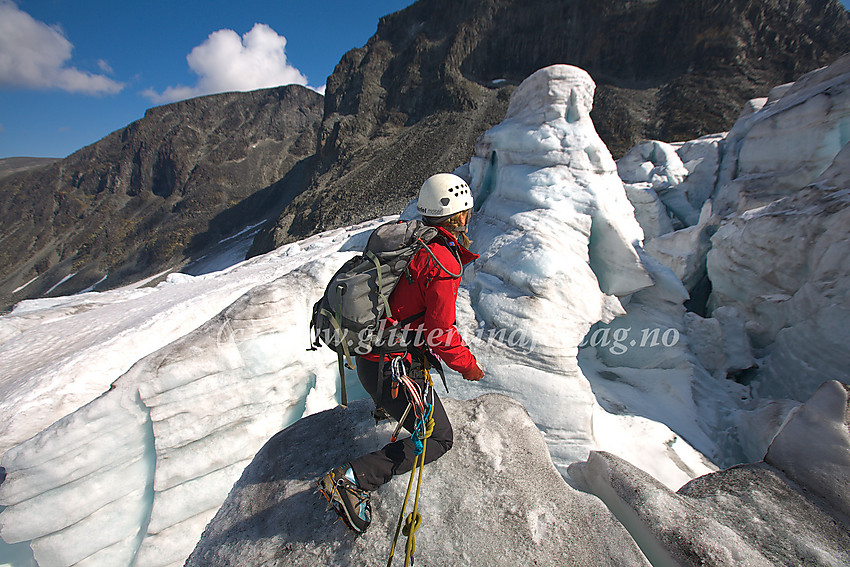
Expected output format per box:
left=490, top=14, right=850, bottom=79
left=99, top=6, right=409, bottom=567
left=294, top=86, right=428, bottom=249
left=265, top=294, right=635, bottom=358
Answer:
left=142, top=24, right=324, bottom=103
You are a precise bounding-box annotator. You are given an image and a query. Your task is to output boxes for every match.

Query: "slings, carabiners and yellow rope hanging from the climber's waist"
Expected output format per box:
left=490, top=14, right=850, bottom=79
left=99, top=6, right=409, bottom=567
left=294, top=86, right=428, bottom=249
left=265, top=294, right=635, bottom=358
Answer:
left=387, top=357, right=434, bottom=567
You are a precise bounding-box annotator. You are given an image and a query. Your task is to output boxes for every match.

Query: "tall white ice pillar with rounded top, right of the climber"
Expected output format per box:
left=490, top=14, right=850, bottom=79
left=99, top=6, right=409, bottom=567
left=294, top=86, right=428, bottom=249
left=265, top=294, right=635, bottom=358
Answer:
left=469, top=65, right=652, bottom=363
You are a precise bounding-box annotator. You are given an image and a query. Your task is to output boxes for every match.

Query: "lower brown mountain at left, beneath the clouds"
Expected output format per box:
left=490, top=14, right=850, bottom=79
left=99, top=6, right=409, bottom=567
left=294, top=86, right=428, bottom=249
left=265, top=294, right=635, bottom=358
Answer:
left=0, top=86, right=322, bottom=305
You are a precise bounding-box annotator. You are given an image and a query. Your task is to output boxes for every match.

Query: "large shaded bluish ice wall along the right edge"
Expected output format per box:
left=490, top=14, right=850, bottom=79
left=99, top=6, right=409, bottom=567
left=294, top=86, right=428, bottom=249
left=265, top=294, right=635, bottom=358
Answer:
left=707, top=56, right=850, bottom=401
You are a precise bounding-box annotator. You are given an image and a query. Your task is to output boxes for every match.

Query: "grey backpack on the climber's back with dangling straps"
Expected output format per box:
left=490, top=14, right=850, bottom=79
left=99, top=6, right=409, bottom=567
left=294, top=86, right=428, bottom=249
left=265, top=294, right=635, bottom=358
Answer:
left=310, top=220, right=460, bottom=406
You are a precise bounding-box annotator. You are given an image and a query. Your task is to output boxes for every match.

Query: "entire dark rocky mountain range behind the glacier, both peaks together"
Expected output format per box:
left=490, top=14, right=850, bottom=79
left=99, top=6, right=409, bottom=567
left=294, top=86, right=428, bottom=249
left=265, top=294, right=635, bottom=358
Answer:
left=0, top=0, right=850, bottom=308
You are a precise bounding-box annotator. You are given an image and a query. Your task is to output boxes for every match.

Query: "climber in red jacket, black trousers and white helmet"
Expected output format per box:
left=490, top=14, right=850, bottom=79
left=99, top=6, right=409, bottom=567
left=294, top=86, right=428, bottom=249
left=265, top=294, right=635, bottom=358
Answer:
left=318, top=173, right=484, bottom=533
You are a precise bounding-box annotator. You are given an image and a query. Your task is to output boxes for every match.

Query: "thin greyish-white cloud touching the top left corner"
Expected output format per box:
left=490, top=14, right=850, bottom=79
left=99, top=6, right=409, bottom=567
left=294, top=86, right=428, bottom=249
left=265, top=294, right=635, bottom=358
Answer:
left=0, top=0, right=124, bottom=94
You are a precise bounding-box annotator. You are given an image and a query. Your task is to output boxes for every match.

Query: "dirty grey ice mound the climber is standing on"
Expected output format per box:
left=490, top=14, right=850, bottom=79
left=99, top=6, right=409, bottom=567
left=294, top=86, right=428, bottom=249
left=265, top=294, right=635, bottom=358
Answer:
left=186, top=394, right=647, bottom=567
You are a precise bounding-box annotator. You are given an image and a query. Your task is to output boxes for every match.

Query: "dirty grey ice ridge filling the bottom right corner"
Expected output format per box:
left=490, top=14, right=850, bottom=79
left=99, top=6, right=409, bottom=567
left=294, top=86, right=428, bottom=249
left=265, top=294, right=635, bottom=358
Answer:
left=569, top=381, right=850, bottom=567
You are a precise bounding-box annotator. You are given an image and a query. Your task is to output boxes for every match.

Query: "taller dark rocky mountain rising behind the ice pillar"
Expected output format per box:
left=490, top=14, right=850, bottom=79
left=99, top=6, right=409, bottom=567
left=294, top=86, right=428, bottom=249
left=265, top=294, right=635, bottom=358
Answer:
left=251, top=0, right=850, bottom=254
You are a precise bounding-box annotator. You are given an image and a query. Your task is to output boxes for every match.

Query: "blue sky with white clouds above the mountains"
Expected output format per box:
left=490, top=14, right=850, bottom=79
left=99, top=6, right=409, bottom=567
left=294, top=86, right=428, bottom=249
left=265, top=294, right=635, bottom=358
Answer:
left=0, top=0, right=850, bottom=158
